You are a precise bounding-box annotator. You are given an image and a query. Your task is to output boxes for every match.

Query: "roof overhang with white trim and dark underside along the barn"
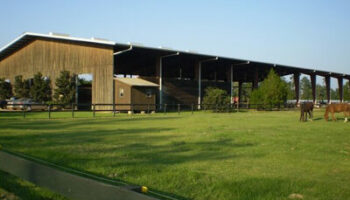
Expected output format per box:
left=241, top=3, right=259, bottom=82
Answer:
left=0, top=32, right=350, bottom=79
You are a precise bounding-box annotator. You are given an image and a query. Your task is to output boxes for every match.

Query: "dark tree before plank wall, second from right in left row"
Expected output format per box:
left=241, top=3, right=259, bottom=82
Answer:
left=30, top=72, right=51, bottom=103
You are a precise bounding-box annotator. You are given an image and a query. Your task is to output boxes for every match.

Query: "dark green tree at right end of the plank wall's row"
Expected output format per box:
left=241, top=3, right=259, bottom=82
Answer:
left=54, top=70, right=76, bottom=104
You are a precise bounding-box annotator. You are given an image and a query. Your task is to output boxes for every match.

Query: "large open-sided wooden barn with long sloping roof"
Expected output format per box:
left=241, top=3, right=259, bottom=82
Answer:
left=0, top=33, right=350, bottom=107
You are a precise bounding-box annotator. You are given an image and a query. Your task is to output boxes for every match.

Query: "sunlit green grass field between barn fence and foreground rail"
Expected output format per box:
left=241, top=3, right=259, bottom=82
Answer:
left=0, top=110, right=350, bottom=200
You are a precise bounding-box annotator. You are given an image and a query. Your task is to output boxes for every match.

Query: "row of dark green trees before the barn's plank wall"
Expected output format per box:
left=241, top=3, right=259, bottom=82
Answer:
left=0, top=70, right=77, bottom=104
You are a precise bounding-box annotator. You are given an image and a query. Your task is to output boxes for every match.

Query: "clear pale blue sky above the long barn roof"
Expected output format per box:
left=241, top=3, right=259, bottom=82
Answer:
left=0, top=0, right=350, bottom=86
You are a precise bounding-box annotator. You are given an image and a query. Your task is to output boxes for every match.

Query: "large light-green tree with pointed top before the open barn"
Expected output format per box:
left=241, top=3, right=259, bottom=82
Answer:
left=251, top=69, right=288, bottom=105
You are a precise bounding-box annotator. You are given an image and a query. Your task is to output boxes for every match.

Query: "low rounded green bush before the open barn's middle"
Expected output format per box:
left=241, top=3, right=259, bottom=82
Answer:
left=203, top=87, right=230, bottom=111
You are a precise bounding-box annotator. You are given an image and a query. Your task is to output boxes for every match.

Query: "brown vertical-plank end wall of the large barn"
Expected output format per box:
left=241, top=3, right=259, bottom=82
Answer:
left=0, top=39, right=113, bottom=104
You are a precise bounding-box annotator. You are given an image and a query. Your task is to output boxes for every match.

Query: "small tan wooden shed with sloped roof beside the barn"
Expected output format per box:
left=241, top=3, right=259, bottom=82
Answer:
left=114, top=78, right=158, bottom=111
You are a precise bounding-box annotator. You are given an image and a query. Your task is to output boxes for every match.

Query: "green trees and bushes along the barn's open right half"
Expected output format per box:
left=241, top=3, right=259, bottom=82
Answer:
left=203, top=69, right=350, bottom=109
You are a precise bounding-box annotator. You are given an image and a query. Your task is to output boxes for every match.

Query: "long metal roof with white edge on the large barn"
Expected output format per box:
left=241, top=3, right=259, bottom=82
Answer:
left=0, top=32, right=350, bottom=79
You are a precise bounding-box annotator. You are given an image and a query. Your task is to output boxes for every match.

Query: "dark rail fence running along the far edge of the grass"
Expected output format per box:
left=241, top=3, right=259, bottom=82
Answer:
left=0, top=103, right=296, bottom=119
